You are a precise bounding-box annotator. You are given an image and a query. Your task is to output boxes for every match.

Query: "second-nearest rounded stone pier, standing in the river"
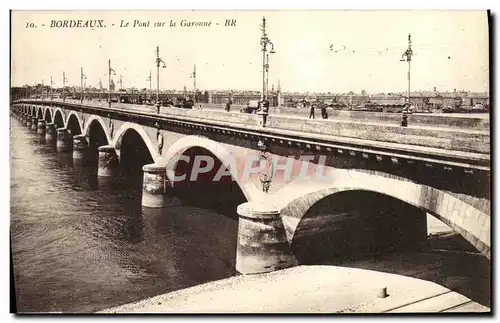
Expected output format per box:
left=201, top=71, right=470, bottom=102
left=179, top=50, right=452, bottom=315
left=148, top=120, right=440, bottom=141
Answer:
left=142, top=164, right=167, bottom=208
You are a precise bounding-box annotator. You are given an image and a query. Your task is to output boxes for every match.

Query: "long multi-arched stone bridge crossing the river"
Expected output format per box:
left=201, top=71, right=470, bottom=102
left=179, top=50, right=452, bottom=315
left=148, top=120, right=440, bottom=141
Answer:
left=11, top=100, right=491, bottom=274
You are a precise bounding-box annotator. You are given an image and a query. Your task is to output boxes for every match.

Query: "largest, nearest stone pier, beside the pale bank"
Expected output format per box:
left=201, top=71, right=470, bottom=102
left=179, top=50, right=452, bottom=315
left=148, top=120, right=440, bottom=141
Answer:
left=236, top=202, right=297, bottom=274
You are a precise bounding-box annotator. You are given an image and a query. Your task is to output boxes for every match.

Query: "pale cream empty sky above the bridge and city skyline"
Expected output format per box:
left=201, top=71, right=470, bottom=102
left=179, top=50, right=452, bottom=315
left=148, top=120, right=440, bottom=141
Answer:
left=11, top=10, right=489, bottom=93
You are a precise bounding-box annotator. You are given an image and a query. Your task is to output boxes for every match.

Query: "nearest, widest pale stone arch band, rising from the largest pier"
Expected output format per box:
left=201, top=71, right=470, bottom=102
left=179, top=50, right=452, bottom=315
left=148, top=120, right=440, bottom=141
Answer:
left=274, top=170, right=491, bottom=258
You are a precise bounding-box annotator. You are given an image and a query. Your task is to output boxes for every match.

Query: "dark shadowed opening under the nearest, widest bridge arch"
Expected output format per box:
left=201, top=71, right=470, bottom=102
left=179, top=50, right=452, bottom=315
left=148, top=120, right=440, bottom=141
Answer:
left=290, top=190, right=427, bottom=264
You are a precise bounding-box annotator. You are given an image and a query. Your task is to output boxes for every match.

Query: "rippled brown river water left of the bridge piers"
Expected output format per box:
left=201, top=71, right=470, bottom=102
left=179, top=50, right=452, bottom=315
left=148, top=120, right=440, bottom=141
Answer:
left=10, top=118, right=238, bottom=312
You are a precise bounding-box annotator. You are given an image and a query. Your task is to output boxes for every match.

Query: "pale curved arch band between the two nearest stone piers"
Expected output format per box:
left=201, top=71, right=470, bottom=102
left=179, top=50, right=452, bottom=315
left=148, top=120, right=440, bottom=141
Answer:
left=159, top=136, right=259, bottom=201
